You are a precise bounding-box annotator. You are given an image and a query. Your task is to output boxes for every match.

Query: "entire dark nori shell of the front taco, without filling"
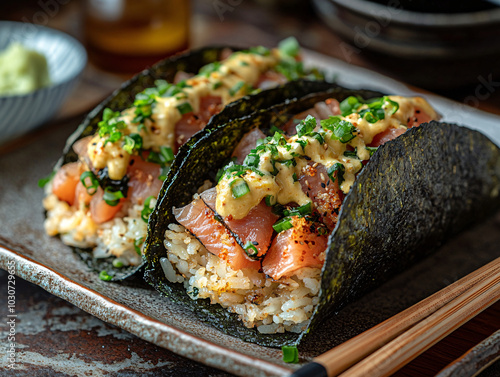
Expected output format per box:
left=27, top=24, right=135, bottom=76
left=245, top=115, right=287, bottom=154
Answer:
left=145, top=88, right=500, bottom=346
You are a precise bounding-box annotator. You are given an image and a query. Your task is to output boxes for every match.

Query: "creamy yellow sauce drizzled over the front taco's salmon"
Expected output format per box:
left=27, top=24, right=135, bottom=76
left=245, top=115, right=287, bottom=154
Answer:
left=216, top=96, right=439, bottom=219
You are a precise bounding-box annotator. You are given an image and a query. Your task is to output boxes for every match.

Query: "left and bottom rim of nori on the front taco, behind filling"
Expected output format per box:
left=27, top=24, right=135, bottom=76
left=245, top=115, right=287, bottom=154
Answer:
left=144, top=86, right=381, bottom=347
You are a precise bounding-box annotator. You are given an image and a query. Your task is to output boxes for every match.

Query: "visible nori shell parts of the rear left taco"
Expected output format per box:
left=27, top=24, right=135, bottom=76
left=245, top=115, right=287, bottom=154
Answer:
left=49, top=46, right=340, bottom=281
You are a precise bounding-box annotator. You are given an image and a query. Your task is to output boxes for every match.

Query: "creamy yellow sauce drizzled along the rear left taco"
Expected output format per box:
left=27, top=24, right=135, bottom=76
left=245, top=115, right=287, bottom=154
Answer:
left=88, top=49, right=280, bottom=180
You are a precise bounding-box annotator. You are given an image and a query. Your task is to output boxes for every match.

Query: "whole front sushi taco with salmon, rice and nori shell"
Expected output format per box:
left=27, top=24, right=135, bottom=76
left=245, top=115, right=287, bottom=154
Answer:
left=145, top=88, right=500, bottom=346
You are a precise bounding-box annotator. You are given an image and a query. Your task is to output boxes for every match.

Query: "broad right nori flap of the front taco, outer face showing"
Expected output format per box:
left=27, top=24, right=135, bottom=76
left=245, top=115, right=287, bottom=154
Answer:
left=298, top=121, right=500, bottom=341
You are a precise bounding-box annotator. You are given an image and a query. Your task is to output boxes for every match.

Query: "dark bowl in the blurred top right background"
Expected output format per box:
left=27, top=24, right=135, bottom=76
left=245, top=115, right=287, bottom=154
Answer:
left=313, top=0, right=500, bottom=89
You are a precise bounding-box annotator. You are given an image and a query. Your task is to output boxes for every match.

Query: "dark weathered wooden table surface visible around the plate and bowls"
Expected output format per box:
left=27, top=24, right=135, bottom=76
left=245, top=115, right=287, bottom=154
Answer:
left=0, top=0, right=500, bottom=377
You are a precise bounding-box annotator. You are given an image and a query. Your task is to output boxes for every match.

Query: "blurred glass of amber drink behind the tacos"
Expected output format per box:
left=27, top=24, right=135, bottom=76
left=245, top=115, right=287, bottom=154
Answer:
left=84, top=0, right=190, bottom=73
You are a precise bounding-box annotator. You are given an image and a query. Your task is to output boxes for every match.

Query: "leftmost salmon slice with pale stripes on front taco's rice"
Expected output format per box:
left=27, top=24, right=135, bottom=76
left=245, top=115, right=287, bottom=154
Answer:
left=173, top=198, right=260, bottom=270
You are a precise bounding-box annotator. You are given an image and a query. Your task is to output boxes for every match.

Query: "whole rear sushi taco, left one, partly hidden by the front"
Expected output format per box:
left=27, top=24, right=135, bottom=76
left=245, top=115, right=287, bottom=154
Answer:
left=43, top=39, right=332, bottom=280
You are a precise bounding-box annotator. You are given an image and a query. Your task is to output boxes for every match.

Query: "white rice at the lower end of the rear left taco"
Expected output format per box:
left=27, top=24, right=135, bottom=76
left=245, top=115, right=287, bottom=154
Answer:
left=43, top=181, right=152, bottom=266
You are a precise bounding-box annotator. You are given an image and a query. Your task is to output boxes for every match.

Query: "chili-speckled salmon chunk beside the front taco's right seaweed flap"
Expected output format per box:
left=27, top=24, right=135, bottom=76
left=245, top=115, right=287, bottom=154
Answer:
left=262, top=216, right=328, bottom=280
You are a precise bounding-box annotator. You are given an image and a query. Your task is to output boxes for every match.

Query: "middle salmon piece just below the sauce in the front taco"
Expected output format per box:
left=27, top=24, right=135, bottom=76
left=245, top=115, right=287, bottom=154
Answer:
left=201, top=188, right=278, bottom=259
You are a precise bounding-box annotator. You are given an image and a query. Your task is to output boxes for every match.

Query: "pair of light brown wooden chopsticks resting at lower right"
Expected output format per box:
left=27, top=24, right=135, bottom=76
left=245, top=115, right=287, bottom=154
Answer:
left=290, top=254, right=500, bottom=377
